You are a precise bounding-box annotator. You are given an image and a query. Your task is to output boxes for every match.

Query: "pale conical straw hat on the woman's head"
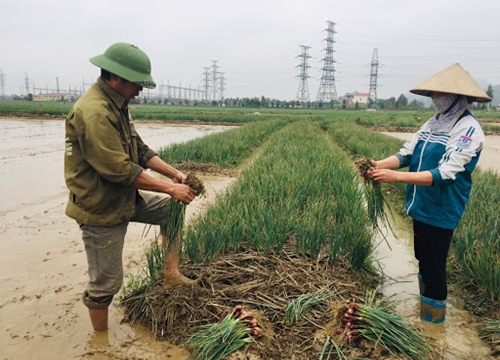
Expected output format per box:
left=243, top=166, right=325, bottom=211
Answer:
left=410, top=63, right=491, bottom=102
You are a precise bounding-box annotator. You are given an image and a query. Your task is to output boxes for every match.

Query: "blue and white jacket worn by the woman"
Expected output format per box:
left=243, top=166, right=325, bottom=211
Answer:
left=396, top=110, right=485, bottom=230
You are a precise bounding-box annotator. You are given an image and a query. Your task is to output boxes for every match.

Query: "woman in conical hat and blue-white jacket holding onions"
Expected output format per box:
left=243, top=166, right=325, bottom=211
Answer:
left=370, top=64, right=491, bottom=323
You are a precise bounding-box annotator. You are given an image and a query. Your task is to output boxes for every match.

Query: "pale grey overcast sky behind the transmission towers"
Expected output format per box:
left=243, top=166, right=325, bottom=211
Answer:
left=0, top=0, right=500, bottom=100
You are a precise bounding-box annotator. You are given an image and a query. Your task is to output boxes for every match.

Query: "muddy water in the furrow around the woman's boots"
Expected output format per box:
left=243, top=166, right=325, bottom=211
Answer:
left=374, top=214, right=491, bottom=360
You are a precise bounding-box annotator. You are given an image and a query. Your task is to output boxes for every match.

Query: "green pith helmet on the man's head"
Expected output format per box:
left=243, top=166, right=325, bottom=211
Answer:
left=90, top=43, right=156, bottom=89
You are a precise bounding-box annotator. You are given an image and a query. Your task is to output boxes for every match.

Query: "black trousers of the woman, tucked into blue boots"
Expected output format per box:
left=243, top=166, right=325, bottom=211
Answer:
left=413, top=219, right=453, bottom=300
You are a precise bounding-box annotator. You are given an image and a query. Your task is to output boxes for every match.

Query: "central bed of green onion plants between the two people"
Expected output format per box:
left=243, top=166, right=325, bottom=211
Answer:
left=185, top=121, right=372, bottom=270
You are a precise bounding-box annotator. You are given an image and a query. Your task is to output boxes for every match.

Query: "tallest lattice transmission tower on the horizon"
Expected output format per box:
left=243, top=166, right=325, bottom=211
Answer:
left=316, top=20, right=337, bottom=103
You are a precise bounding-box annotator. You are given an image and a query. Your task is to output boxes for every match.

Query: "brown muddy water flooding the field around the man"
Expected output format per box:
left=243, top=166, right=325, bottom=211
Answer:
left=0, top=118, right=234, bottom=360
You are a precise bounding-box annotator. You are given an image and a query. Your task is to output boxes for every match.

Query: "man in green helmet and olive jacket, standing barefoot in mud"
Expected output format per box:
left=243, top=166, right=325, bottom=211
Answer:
left=64, top=43, right=196, bottom=331
